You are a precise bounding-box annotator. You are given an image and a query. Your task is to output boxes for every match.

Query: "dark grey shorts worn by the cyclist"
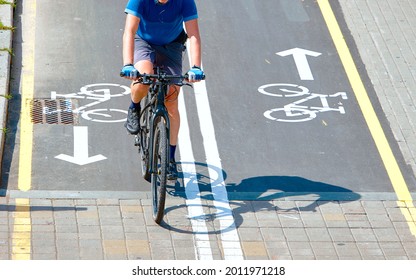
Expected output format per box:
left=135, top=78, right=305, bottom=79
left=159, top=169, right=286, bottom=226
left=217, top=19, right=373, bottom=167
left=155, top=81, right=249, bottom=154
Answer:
left=134, top=35, right=186, bottom=75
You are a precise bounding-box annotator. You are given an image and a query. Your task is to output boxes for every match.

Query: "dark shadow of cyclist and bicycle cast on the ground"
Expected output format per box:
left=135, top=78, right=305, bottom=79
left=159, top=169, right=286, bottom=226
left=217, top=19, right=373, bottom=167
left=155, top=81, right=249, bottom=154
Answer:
left=162, top=163, right=361, bottom=234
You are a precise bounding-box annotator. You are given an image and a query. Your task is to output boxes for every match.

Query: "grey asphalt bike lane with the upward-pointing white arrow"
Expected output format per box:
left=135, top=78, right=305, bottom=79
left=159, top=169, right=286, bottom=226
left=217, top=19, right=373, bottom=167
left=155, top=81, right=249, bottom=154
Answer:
left=188, top=0, right=414, bottom=200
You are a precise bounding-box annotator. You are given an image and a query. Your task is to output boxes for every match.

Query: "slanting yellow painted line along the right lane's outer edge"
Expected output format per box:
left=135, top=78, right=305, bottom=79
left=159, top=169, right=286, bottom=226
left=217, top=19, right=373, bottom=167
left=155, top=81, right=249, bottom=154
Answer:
left=318, top=0, right=416, bottom=236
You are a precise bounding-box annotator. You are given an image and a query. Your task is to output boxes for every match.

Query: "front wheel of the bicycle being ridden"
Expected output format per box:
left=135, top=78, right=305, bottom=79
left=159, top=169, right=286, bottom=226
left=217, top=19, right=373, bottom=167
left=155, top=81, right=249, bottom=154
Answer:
left=151, top=117, right=169, bottom=224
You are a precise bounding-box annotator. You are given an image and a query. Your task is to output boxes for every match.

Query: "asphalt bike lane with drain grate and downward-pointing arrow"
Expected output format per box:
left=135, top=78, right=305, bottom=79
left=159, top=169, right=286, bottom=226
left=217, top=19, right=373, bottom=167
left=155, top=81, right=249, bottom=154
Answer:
left=9, top=1, right=147, bottom=192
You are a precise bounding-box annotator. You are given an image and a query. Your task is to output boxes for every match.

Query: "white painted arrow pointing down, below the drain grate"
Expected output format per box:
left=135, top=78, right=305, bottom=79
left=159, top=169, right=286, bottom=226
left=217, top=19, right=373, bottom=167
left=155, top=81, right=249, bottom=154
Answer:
left=55, top=126, right=107, bottom=165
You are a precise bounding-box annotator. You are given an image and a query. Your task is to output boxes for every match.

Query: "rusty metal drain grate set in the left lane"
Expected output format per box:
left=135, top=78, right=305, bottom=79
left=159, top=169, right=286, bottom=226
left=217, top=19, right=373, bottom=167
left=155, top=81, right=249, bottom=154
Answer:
left=31, top=99, right=75, bottom=124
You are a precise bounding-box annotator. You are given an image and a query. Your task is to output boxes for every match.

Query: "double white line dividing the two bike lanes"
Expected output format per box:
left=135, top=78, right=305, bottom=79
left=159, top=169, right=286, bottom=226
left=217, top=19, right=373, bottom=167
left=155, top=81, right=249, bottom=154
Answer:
left=178, top=46, right=244, bottom=260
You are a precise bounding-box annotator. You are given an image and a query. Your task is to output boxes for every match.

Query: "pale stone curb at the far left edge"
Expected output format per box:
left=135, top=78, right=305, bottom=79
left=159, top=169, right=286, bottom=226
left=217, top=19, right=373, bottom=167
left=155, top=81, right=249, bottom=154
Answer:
left=0, top=4, right=13, bottom=175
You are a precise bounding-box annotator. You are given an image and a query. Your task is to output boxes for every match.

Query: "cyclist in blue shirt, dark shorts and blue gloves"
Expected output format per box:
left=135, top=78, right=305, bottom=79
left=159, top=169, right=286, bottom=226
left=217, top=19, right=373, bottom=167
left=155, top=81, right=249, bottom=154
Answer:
left=121, top=0, right=204, bottom=180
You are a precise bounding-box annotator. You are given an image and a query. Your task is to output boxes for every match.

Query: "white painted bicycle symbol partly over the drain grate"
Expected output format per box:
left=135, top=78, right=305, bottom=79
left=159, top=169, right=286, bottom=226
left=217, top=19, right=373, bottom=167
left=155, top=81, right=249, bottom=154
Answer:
left=51, top=83, right=130, bottom=123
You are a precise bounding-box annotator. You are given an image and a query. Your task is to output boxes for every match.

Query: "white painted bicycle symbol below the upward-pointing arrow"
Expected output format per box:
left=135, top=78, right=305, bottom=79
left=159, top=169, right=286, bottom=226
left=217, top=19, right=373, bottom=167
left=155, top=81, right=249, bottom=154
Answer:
left=258, top=83, right=348, bottom=122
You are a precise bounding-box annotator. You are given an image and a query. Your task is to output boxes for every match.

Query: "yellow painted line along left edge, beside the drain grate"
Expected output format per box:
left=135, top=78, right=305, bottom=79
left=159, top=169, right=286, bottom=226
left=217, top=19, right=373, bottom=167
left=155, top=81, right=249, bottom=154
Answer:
left=11, top=0, right=36, bottom=260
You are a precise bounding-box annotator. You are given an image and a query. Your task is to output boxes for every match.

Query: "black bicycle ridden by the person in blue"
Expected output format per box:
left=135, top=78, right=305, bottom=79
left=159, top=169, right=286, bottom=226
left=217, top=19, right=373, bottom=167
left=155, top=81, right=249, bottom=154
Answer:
left=120, top=67, right=202, bottom=224
